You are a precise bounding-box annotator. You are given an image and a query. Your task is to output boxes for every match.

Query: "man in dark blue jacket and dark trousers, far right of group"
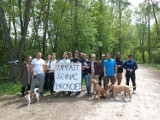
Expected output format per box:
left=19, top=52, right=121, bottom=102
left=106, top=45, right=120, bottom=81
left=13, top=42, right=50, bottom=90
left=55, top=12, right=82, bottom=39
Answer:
left=124, top=55, right=138, bottom=94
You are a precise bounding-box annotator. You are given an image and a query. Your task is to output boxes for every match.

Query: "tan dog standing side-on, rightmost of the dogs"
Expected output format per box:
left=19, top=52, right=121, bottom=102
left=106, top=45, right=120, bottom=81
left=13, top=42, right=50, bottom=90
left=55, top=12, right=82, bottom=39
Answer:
left=108, top=84, right=132, bottom=101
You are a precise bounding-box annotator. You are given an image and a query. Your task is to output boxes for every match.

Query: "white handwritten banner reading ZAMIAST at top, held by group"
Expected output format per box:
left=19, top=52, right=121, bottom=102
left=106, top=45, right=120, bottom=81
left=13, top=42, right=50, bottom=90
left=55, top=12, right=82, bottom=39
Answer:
left=54, top=63, right=82, bottom=91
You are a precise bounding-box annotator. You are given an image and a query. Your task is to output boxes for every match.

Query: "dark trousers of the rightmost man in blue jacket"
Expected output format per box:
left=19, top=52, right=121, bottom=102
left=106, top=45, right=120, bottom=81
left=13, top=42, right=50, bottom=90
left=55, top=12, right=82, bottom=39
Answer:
left=126, top=75, right=136, bottom=90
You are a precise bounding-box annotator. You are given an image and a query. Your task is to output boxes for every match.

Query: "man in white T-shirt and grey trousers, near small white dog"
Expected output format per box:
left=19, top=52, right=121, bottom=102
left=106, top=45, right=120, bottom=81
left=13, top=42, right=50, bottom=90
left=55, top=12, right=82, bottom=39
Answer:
left=31, top=52, right=45, bottom=96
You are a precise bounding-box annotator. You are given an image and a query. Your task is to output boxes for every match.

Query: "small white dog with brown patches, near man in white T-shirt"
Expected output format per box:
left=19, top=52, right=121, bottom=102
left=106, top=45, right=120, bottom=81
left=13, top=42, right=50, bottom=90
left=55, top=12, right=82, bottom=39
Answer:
left=24, top=88, right=40, bottom=106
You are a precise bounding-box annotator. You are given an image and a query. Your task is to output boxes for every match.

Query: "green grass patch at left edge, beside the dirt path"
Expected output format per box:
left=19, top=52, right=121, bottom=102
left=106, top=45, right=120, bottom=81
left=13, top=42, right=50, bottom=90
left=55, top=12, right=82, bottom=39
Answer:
left=0, top=81, right=22, bottom=96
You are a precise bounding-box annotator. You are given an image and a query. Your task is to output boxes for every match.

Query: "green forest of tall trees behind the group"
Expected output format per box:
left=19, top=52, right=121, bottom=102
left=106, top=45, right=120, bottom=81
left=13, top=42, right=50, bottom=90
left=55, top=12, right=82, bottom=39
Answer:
left=0, top=0, right=160, bottom=81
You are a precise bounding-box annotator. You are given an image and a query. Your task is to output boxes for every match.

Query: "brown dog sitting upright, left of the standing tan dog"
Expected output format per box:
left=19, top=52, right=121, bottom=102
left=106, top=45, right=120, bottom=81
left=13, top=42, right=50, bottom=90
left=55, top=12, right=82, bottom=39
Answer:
left=92, top=79, right=107, bottom=100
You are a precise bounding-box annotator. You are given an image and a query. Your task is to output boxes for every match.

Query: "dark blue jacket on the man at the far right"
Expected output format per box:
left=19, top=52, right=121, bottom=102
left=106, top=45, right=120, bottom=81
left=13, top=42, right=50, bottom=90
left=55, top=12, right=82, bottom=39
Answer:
left=123, top=60, right=138, bottom=75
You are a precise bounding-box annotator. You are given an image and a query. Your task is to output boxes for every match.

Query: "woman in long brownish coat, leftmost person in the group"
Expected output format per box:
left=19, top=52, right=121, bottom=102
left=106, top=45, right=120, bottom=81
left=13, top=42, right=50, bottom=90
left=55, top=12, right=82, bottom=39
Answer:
left=19, top=56, right=32, bottom=97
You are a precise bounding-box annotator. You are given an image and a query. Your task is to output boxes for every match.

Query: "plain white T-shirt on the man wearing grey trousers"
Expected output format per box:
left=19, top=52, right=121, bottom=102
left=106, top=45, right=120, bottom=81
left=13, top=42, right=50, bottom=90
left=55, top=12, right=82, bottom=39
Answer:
left=31, top=58, right=45, bottom=74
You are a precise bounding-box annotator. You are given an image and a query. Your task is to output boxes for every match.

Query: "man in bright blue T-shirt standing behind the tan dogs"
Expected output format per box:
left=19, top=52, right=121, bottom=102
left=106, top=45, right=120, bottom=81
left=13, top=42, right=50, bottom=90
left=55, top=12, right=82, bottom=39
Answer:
left=104, top=54, right=117, bottom=89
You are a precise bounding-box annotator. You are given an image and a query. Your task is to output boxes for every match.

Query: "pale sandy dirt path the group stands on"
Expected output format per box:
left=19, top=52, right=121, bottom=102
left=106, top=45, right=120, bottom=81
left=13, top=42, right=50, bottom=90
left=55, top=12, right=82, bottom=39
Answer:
left=0, top=65, right=160, bottom=120
